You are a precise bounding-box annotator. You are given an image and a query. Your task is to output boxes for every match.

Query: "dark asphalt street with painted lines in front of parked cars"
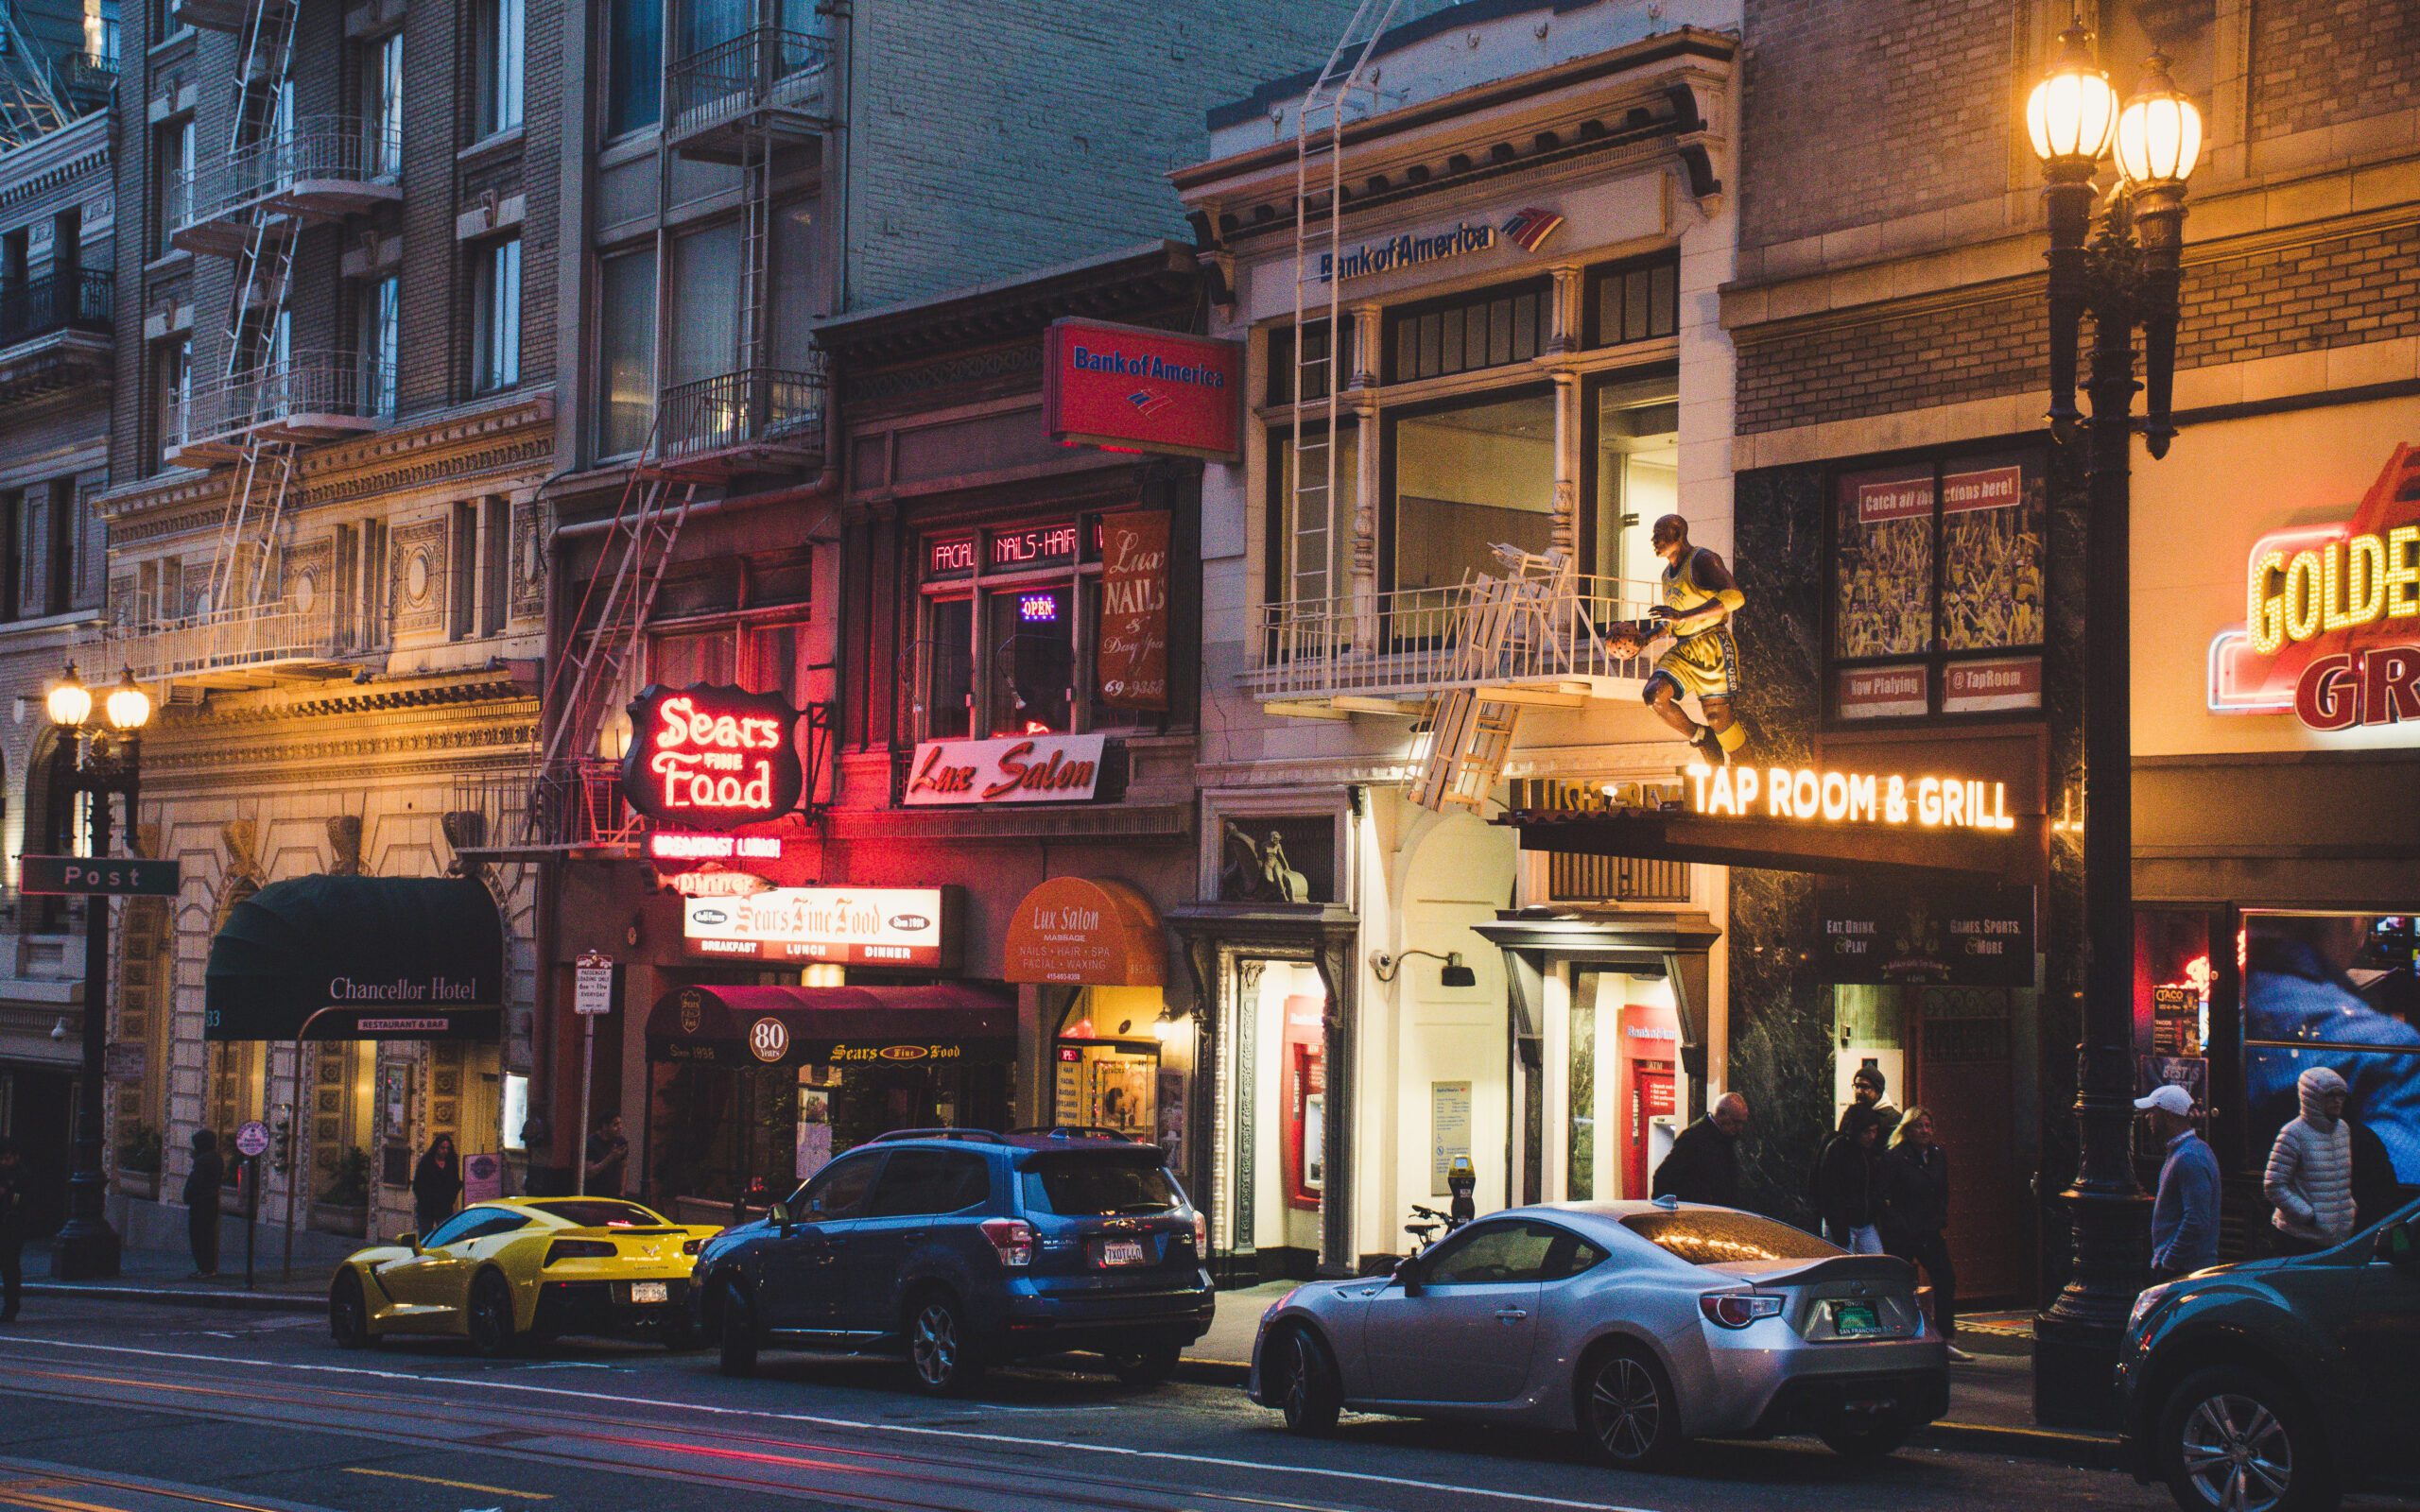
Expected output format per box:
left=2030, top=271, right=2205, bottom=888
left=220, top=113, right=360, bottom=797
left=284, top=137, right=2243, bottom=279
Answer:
left=0, top=1299, right=2361, bottom=1512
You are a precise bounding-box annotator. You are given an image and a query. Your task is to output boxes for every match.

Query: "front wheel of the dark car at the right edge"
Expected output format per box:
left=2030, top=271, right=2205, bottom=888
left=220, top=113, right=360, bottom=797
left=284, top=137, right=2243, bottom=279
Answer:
left=2159, top=1365, right=2338, bottom=1512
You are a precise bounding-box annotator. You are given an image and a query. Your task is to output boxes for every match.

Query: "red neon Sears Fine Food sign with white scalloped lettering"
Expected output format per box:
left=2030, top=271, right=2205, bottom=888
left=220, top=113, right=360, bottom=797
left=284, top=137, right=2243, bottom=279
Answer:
left=622, top=682, right=805, bottom=830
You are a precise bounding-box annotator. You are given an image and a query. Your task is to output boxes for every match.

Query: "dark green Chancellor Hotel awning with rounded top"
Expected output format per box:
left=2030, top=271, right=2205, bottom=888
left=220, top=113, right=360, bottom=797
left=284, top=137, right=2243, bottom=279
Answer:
left=200, top=876, right=503, bottom=1040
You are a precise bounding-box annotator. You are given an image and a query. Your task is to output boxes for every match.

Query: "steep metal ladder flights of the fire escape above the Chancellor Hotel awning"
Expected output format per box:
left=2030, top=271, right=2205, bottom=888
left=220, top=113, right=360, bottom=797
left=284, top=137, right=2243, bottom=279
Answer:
left=196, top=0, right=300, bottom=634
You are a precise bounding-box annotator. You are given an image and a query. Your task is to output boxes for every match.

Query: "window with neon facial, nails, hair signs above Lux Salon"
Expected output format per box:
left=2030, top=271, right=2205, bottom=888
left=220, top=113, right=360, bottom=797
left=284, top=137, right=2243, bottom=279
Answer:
left=915, top=515, right=1159, bottom=740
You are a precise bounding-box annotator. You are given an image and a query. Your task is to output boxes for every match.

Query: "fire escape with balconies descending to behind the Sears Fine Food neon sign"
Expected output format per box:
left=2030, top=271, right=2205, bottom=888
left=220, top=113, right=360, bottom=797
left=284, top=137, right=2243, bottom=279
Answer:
left=458, top=0, right=838, bottom=859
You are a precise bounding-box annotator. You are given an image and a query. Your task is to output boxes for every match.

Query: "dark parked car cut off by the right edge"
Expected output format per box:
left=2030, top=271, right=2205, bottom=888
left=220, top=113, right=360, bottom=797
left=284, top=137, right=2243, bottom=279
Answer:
left=2118, top=1207, right=2420, bottom=1512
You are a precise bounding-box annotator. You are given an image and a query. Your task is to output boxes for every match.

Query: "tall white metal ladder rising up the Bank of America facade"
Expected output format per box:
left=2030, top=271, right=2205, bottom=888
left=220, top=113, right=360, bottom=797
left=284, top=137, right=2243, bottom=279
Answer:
left=1283, top=0, right=1401, bottom=624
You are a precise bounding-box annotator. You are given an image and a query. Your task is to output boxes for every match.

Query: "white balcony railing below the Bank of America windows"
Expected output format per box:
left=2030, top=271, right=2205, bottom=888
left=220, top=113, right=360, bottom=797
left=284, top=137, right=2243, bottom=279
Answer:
left=1239, top=576, right=1655, bottom=712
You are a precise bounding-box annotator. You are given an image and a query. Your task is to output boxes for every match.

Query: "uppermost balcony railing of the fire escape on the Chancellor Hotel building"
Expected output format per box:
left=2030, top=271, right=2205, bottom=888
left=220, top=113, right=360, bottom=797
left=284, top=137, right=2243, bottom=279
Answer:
left=169, top=116, right=402, bottom=251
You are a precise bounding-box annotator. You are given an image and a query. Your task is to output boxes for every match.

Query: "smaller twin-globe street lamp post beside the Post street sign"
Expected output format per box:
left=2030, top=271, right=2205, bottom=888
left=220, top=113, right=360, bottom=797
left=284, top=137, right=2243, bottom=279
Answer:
left=46, top=662, right=150, bottom=1280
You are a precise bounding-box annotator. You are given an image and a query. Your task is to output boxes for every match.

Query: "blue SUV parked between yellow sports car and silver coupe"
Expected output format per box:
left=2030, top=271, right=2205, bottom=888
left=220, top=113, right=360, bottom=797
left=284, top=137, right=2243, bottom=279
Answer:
left=690, top=1127, right=1213, bottom=1396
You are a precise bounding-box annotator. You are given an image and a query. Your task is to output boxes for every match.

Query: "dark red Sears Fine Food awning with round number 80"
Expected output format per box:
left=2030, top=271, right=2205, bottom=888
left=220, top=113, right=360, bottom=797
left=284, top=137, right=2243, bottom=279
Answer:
left=647, top=982, right=1016, bottom=1067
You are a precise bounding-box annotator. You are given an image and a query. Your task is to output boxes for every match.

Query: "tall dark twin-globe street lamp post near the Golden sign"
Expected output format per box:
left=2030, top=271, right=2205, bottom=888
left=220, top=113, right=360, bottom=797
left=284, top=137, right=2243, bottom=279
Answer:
left=2026, top=25, right=2203, bottom=1425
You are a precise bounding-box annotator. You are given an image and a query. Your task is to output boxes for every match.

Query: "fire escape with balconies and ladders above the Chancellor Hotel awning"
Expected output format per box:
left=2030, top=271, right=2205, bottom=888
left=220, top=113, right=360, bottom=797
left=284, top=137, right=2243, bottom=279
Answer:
left=109, top=0, right=402, bottom=696
